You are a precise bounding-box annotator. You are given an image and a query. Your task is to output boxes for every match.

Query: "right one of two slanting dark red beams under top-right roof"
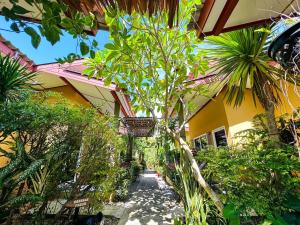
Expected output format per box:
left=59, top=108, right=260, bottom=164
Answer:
left=213, top=0, right=239, bottom=35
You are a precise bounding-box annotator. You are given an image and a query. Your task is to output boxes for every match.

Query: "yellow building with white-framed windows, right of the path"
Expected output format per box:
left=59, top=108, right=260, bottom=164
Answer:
left=187, top=81, right=300, bottom=149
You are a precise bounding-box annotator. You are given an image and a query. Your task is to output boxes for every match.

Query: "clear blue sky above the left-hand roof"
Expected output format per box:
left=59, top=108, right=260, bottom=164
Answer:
left=0, top=16, right=109, bottom=64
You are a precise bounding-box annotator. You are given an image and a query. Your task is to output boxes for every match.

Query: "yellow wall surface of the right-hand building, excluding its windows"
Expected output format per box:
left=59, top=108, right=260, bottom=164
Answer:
left=188, top=82, right=300, bottom=144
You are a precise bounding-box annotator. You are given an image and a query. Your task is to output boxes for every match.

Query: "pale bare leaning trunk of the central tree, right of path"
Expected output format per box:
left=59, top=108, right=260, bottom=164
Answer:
left=166, top=128, right=224, bottom=213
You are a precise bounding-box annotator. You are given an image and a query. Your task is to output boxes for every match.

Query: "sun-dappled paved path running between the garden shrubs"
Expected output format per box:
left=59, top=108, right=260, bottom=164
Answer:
left=118, top=170, right=183, bottom=225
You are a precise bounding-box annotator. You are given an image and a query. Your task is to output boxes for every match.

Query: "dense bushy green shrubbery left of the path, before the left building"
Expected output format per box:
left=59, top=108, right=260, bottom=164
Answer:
left=0, top=94, right=125, bottom=224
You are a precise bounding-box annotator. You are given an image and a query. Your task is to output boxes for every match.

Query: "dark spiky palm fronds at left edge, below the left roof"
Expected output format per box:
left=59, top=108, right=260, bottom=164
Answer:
left=0, top=54, right=35, bottom=103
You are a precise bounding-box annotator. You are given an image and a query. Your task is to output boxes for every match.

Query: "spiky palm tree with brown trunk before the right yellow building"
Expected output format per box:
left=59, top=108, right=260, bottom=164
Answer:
left=207, top=27, right=280, bottom=141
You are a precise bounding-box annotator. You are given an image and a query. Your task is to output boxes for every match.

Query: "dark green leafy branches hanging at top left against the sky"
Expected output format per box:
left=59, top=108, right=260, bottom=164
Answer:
left=1, top=0, right=98, bottom=58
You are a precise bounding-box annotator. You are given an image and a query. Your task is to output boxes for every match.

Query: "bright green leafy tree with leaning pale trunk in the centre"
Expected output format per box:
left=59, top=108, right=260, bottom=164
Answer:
left=85, top=1, right=222, bottom=211
